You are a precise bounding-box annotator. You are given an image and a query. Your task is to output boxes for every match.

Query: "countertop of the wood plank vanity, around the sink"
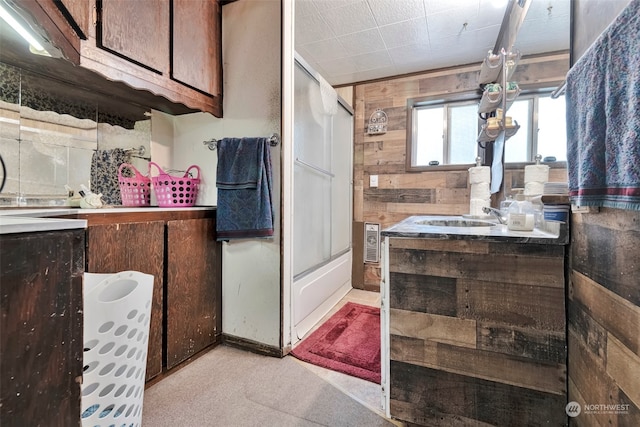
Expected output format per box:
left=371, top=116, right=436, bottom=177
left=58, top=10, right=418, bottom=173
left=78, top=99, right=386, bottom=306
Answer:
left=380, top=215, right=569, bottom=245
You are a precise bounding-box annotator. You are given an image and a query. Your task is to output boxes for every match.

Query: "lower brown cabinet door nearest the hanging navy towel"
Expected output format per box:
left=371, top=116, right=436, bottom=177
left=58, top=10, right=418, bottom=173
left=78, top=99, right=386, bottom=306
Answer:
left=165, top=219, right=222, bottom=369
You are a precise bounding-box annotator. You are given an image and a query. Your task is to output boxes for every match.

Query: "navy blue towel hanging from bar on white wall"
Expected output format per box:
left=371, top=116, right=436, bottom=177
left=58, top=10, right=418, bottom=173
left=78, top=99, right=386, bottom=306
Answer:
left=216, top=138, right=273, bottom=241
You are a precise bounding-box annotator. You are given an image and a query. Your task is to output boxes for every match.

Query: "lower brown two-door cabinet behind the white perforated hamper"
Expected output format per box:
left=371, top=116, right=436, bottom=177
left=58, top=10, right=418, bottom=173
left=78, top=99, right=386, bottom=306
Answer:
left=81, top=210, right=222, bottom=381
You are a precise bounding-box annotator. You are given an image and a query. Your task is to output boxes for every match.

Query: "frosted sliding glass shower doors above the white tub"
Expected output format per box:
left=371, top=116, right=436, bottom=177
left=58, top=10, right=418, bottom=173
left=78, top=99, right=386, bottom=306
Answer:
left=294, top=63, right=353, bottom=277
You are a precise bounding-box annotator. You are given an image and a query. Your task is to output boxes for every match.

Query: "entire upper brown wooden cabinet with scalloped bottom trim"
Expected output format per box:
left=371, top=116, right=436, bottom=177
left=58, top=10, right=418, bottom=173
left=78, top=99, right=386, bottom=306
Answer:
left=14, top=0, right=222, bottom=117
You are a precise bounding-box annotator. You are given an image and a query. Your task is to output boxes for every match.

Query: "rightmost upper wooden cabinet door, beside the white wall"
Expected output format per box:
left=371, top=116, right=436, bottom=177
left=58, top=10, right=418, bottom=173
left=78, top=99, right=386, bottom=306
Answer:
left=171, top=0, right=222, bottom=96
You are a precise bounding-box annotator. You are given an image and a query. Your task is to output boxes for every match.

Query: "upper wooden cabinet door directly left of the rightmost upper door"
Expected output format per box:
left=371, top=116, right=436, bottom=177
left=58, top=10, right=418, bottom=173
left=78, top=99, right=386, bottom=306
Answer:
left=96, top=0, right=170, bottom=76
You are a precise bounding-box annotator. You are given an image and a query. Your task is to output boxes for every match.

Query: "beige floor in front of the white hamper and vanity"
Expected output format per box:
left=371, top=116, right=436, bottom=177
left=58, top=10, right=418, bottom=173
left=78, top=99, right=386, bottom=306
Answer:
left=142, top=346, right=397, bottom=427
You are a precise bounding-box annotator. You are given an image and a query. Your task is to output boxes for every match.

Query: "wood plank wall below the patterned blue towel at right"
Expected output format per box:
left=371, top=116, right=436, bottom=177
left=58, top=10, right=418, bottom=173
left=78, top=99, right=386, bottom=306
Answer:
left=568, top=208, right=640, bottom=426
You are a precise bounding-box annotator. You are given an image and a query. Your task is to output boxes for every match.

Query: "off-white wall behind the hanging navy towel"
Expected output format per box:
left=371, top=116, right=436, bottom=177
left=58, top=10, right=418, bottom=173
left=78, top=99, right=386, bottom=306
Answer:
left=152, top=0, right=282, bottom=348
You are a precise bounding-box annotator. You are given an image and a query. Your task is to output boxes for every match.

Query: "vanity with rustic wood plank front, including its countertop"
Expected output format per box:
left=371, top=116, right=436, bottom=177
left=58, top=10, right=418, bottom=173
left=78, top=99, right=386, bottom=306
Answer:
left=381, top=217, right=568, bottom=426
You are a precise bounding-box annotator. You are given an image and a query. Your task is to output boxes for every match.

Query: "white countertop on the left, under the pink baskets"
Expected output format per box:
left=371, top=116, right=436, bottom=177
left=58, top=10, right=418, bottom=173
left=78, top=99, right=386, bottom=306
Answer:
left=0, top=206, right=215, bottom=234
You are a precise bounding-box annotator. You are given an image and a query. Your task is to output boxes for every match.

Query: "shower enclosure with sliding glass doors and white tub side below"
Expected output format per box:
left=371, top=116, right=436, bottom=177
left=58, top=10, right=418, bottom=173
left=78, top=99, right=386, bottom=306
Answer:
left=293, top=59, right=353, bottom=340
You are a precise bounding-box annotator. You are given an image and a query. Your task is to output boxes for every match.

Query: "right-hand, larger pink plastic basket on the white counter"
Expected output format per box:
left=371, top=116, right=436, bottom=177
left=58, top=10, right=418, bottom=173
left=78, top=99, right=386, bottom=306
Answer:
left=149, top=162, right=200, bottom=208
